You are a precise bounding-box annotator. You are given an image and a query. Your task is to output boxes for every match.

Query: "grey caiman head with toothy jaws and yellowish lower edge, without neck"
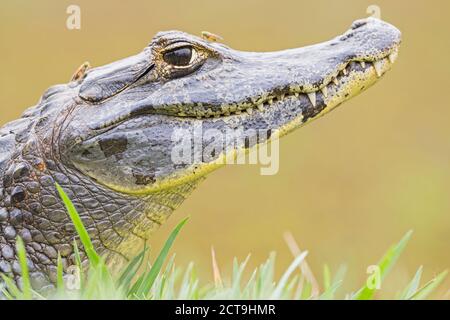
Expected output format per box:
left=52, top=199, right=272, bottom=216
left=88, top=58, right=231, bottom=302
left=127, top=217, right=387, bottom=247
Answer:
left=60, top=18, right=400, bottom=194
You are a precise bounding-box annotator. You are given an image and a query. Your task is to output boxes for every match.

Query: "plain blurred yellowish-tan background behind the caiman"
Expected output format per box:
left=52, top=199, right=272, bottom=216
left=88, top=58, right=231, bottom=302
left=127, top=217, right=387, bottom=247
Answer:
left=0, top=0, right=450, bottom=294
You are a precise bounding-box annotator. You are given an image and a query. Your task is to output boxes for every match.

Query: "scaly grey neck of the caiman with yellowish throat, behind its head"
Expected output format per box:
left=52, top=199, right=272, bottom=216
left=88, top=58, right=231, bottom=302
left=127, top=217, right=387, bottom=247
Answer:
left=0, top=94, right=200, bottom=290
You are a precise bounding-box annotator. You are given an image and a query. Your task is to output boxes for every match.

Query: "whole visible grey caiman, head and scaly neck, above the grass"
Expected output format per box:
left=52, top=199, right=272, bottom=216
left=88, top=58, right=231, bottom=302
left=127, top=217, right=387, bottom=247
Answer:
left=0, top=18, right=401, bottom=290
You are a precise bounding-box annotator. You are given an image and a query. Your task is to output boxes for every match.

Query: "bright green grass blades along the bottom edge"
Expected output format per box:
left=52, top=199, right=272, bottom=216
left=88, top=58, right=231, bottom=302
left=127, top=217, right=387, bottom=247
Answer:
left=1, top=186, right=447, bottom=300
